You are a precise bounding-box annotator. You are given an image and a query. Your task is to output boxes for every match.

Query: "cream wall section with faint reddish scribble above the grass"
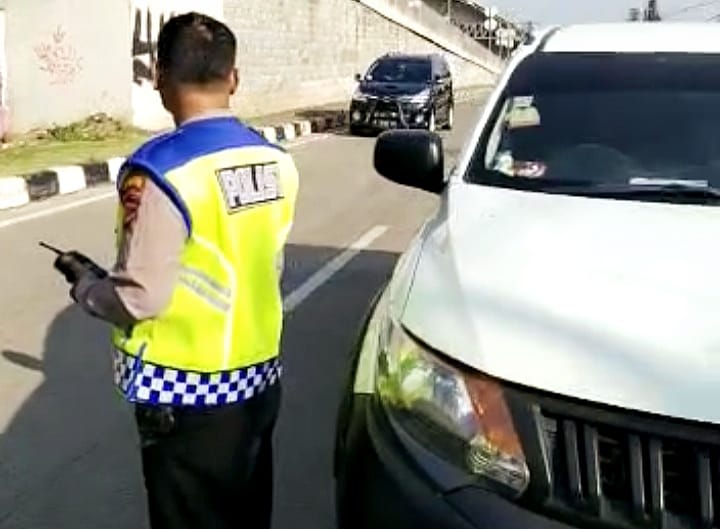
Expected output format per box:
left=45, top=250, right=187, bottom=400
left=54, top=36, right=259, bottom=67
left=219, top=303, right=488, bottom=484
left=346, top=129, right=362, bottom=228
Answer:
left=6, top=0, right=131, bottom=131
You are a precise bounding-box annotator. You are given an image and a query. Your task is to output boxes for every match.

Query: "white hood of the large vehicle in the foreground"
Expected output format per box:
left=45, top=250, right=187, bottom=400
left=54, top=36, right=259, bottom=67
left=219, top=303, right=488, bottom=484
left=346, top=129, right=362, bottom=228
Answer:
left=401, top=184, right=720, bottom=423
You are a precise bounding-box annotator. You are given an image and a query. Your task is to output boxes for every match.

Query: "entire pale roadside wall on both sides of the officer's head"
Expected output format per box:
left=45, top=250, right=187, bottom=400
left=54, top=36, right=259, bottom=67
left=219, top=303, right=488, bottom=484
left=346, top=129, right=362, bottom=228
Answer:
left=0, top=0, right=500, bottom=132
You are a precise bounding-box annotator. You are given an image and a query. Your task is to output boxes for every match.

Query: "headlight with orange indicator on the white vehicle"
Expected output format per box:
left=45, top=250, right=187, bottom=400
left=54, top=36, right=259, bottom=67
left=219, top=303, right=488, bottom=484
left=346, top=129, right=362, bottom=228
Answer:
left=375, top=318, right=530, bottom=497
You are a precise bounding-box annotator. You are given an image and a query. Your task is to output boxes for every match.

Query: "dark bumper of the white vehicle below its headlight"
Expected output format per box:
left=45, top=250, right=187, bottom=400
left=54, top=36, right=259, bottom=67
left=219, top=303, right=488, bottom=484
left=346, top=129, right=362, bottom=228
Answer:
left=337, top=395, right=574, bottom=529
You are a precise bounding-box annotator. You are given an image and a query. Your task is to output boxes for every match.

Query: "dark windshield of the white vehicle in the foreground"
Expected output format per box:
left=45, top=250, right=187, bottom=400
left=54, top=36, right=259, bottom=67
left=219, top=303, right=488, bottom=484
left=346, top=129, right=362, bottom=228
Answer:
left=468, top=53, right=720, bottom=204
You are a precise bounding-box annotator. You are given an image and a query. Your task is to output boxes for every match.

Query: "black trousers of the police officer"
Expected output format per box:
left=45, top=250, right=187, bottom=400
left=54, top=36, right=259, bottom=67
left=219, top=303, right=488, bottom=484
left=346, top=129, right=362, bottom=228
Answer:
left=135, top=382, right=281, bottom=529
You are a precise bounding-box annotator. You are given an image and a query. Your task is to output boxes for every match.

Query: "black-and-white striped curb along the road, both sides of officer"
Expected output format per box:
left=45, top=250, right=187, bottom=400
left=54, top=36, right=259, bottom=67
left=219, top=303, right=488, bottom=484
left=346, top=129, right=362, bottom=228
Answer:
left=0, top=111, right=346, bottom=211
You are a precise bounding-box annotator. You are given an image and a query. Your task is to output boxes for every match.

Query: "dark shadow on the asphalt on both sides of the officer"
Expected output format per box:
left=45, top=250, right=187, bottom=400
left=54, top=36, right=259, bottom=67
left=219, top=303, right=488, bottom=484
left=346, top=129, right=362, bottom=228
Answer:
left=0, top=245, right=397, bottom=529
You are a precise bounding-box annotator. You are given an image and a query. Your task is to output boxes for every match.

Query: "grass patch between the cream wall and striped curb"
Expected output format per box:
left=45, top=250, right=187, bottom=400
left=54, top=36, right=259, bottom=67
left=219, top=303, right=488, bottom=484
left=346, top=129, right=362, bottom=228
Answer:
left=0, top=114, right=149, bottom=177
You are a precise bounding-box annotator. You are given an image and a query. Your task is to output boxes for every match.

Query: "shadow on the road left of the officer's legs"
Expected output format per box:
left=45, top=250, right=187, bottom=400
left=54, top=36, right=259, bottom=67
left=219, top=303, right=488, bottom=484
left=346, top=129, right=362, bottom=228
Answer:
left=0, top=307, right=144, bottom=529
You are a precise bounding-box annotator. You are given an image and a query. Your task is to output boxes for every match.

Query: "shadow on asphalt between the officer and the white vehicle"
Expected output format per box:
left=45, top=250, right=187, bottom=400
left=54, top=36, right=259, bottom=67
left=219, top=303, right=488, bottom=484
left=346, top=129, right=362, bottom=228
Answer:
left=274, top=243, right=398, bottom=529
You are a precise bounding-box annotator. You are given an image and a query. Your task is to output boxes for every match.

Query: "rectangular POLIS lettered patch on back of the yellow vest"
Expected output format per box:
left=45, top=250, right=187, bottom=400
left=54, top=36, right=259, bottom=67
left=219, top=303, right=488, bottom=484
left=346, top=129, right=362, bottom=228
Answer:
left=216, top=162, right=283, bottom=213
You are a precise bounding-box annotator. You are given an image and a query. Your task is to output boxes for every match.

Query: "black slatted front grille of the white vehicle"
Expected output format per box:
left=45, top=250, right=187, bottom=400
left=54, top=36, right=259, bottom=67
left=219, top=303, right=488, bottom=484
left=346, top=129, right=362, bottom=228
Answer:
left=539, top=409, right=720, bottom=529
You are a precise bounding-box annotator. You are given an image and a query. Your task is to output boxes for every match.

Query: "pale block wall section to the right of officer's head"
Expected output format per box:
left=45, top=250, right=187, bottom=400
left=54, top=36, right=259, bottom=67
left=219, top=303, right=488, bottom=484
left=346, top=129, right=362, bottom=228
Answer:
left=225, top=0, right=499, bottom=116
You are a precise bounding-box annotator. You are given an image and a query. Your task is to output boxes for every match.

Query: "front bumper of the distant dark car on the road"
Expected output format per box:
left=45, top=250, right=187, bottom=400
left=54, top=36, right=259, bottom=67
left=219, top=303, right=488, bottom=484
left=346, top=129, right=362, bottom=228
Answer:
left=349, top=101, right=430, bottom=131
